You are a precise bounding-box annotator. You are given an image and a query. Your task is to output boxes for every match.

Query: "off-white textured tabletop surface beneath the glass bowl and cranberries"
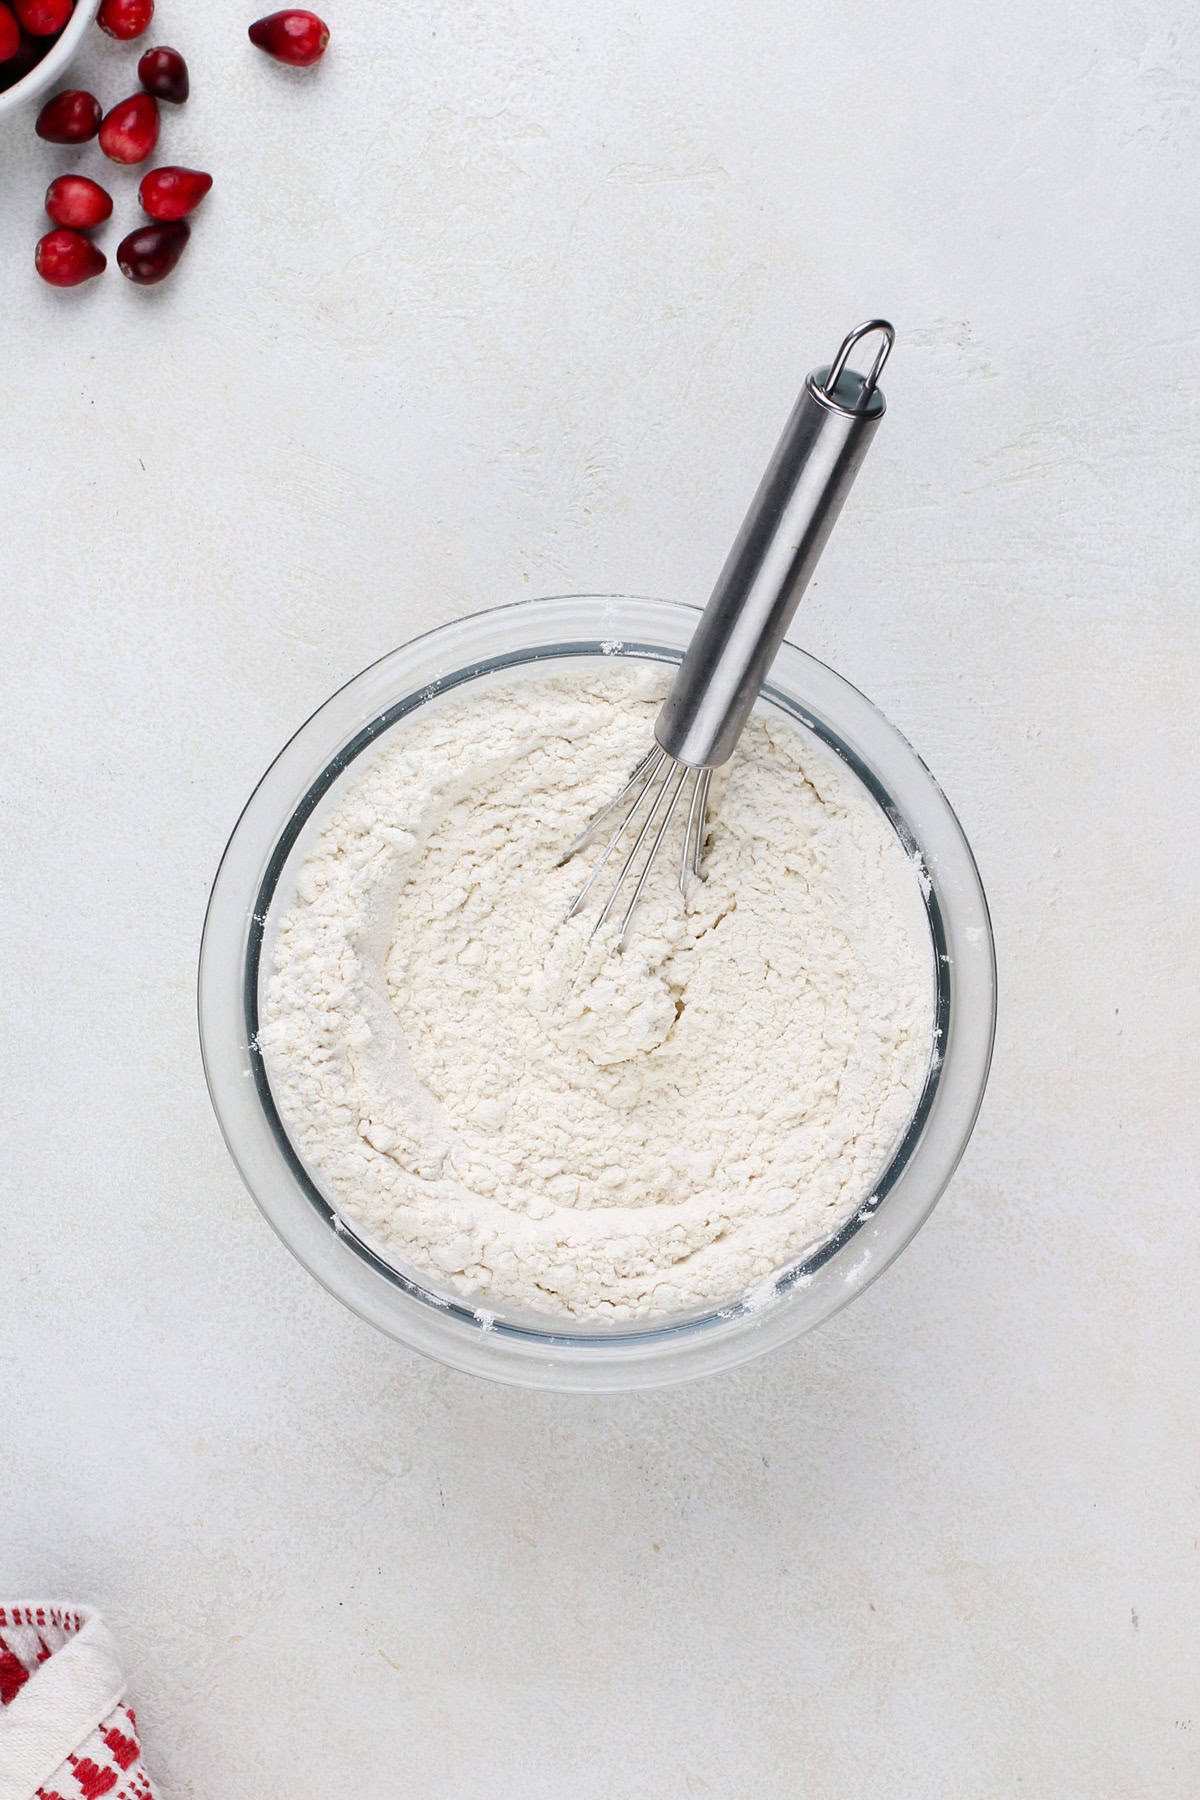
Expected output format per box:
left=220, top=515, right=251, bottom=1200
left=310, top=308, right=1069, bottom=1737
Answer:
left=0, top=0, right=1200, bottom=1800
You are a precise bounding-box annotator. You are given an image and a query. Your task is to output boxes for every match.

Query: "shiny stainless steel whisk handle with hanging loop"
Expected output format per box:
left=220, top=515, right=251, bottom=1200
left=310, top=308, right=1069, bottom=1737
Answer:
left=655, top=319, right=894, bottom=769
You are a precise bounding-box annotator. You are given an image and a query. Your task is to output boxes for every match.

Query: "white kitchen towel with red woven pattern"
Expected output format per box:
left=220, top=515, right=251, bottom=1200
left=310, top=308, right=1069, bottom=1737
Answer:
left=0, top=1600, right=155, bottom=1800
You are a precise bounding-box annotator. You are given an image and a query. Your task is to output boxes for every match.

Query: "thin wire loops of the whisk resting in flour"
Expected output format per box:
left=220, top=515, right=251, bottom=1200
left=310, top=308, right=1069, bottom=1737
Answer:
left=556, top=743, right=712, bottom=943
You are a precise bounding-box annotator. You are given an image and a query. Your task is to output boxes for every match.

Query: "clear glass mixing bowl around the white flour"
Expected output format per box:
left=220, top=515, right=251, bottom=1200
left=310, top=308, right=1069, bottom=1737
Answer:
left=198, top=594, right=995, bottom=1391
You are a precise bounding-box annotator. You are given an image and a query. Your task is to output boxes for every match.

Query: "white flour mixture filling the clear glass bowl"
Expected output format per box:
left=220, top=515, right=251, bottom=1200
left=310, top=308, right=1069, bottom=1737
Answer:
left=259, top=662, right=934, bottom=1323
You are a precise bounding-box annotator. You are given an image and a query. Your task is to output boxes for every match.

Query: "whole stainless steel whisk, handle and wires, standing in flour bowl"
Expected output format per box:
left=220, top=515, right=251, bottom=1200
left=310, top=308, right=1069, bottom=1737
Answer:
left=558, top=319, right=896, bottom=943
